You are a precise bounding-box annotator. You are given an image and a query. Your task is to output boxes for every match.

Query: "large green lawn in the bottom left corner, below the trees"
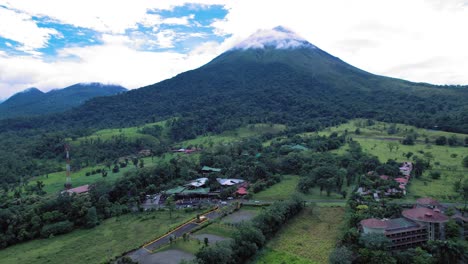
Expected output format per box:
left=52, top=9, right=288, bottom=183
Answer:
left=0, top=211, right=201, bottom=264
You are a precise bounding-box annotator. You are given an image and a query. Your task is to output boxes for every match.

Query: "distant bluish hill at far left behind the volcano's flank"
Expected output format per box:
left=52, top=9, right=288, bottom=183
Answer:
left=0, top=83, right=127, bottom=119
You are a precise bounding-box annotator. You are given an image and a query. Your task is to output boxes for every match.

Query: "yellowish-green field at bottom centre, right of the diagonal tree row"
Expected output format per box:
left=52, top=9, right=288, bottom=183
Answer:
left=253, top=207, right=344, bottom=264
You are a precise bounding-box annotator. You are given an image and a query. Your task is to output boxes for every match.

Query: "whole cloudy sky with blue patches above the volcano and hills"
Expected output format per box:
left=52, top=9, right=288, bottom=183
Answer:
left=0, top=0, right=468, bottom=99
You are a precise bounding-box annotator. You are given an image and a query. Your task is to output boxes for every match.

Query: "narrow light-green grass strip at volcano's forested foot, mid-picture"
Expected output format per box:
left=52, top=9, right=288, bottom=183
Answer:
left=179, top=124, right=286, bottom=148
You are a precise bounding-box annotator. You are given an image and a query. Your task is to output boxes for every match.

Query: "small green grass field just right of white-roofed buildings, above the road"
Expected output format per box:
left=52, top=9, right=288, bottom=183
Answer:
left=252, top=175, right=353, bottom=201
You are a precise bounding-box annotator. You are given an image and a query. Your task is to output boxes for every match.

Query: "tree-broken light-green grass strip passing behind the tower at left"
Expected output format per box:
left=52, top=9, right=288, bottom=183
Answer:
left=29, top=153, right=185, bottom=195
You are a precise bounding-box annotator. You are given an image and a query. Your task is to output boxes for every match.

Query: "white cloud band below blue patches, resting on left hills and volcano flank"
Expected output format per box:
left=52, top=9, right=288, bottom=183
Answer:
left=0, top=37, right=219, bottom=97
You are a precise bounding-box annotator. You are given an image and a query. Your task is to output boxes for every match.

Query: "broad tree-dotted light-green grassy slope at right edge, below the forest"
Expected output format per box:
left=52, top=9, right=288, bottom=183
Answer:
left=322, top=121, right=468, bottom=201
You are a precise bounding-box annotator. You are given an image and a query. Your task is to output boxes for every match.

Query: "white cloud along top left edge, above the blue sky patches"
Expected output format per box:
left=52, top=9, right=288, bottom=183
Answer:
left=0, top=0, right=224, bottom=34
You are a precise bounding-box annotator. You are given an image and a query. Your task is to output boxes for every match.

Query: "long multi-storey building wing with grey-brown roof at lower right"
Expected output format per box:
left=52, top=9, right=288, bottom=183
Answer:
left=361, top=218, right=428, bottom=249
